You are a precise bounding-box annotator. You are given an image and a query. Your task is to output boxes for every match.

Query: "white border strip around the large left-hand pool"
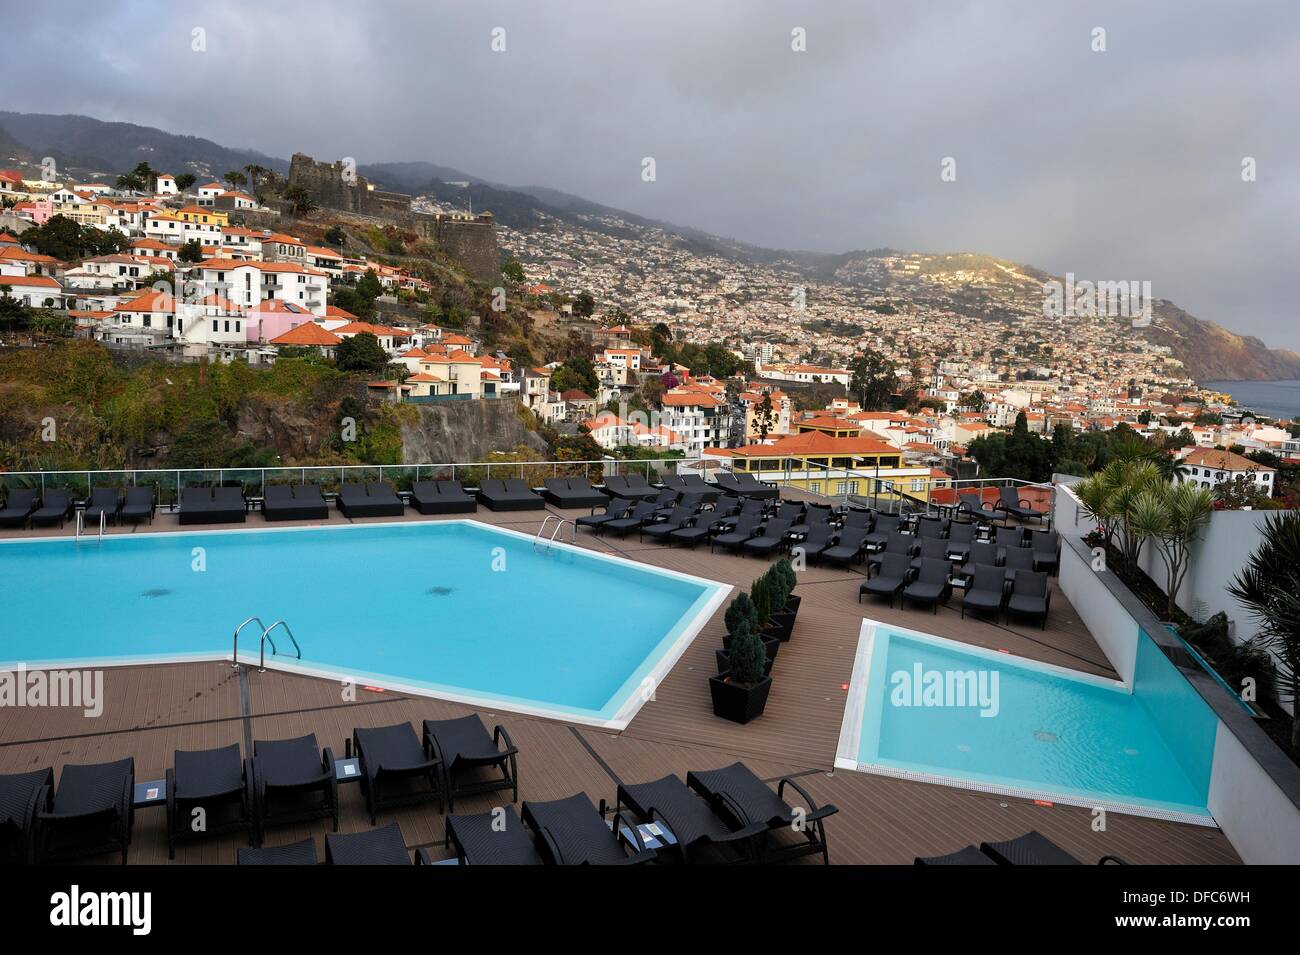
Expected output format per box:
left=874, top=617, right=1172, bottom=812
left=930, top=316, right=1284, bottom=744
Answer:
left=0, top=518, right=733, bottom=732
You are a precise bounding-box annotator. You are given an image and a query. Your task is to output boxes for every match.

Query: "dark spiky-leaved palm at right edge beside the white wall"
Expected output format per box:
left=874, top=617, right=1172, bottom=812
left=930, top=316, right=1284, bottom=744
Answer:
left=1227, top=511, right=1300, bottom=755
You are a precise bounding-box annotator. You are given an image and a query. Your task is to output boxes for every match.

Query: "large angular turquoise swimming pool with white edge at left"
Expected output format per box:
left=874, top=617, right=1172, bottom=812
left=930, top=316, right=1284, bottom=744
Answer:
left=0, top=521, right=731, bottom=729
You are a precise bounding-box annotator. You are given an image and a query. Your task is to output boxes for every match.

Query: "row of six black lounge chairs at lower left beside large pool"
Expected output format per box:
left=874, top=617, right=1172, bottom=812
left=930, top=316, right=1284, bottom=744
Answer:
left=0, top=716, right=519, bottom=865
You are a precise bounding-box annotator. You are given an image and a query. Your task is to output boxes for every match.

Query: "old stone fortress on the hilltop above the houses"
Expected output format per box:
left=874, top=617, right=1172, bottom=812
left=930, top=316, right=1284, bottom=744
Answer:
left=289, top=152, right=501, bottom=283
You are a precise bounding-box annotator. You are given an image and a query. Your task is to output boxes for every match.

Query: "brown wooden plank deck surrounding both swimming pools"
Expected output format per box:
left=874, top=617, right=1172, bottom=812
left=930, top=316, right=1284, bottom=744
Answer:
left=0, top=508, right=1239, bottom=864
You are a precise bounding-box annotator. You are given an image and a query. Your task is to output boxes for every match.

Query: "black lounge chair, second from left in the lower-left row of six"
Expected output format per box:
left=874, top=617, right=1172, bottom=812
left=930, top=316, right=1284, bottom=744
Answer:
left=35, top=756, right=135, bottom=865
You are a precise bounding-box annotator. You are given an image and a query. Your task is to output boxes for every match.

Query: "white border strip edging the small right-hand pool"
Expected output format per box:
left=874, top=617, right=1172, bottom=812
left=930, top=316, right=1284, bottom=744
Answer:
left=835, top=617, right=1218, bottom=829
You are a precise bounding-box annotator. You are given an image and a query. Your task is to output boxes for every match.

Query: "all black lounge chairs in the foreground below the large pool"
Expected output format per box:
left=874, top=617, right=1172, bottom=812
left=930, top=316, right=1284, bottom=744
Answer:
left=0, top=715, right=837, bottom=865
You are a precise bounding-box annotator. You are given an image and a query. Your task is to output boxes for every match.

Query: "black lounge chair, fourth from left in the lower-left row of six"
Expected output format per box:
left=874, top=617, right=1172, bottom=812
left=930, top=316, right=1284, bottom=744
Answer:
left=248, top=734, right=338, bottom=846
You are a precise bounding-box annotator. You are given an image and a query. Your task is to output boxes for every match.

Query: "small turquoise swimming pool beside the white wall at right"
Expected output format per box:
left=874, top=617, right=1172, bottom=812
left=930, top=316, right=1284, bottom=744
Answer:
left=836, top=621, right=1217, bottom=825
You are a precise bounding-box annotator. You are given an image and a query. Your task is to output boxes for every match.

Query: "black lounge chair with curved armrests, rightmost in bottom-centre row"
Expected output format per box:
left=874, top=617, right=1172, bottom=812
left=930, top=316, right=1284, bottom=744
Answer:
left=686, top=763, right=839, bottom=865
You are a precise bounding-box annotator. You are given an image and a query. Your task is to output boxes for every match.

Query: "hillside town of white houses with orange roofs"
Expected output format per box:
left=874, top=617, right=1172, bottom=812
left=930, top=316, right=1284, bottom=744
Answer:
left=0, top=157, right=1300, bottom=509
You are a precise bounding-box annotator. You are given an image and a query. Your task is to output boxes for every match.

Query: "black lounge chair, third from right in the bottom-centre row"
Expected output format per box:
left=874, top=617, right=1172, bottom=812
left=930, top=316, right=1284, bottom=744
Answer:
left=523, top=793, right=658, bottom=865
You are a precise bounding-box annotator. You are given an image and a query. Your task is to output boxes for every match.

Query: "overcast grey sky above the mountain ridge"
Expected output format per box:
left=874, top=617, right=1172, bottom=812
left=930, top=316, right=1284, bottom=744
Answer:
left=10, top=0, right=1300, bottom=350
